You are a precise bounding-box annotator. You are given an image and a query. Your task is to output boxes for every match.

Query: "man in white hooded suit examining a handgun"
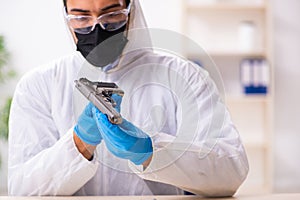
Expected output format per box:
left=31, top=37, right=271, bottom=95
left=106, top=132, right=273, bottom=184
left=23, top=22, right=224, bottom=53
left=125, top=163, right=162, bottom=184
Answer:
left=8, top=0, right=248, bottom=196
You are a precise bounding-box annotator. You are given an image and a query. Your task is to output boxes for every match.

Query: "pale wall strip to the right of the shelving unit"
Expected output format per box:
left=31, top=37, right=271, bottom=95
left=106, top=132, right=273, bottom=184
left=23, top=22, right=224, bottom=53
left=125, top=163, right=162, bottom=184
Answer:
left=274, top=0, right=300, bottom=192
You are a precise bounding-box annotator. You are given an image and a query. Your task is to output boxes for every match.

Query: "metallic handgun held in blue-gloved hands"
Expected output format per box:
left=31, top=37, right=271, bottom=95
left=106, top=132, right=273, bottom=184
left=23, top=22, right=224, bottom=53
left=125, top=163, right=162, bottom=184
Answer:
left=75, top=78, right=124, bottom=124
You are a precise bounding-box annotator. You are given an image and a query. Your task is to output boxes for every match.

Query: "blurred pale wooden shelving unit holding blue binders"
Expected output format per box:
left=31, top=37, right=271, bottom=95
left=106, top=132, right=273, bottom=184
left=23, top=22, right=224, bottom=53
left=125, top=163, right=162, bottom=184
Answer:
left=182, top=0, right=274, bottom=194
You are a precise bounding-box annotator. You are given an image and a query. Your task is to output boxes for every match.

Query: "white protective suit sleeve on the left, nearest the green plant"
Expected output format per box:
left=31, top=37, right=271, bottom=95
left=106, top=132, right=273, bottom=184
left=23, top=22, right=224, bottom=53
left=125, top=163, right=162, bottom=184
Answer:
left=8, top=69, right=98, bottom=196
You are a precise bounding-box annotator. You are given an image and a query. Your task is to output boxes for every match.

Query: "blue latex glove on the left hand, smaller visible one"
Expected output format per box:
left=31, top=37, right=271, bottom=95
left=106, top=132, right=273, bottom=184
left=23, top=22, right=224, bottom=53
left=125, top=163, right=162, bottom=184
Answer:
left=74, top=103, right=102, bottom=146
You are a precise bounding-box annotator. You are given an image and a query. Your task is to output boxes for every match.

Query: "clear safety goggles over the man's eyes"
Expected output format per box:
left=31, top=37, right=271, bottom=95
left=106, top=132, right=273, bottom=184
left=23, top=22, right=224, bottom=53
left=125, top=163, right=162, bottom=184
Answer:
left=64, top=3, right=131, bottom=34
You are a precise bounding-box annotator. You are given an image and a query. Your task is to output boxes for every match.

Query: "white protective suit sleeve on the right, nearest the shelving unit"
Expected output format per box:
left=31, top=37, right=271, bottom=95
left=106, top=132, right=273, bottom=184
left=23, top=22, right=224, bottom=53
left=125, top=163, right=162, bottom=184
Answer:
left=130, top=63, right=249, bottom=197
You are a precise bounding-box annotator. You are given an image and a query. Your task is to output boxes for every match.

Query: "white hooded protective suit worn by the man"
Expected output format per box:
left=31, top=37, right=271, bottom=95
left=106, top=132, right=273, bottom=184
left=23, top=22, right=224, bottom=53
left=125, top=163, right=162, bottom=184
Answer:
left=8, top=0, right=248, bottom=196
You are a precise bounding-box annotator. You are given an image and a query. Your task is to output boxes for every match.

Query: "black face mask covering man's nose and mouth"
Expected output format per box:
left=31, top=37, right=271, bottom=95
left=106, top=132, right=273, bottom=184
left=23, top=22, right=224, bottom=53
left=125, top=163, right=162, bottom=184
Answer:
left=75, top=24, right=128, bottom=67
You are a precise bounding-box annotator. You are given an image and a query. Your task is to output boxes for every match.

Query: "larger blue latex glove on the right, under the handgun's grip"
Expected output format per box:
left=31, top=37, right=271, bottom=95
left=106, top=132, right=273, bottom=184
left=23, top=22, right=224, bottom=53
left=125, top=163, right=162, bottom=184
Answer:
left=93, top=94, right=153, bottom=165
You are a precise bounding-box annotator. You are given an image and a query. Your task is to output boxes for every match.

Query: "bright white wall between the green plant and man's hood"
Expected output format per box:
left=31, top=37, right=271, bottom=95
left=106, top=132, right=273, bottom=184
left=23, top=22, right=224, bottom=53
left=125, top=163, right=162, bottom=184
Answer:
left=0, top=0, right=73, bottom=97
